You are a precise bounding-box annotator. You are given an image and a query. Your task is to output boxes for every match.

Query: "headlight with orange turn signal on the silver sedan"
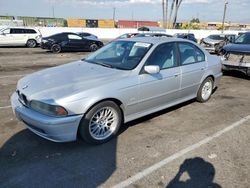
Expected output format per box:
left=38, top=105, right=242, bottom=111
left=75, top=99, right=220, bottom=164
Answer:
left=30, top=100, right=68, bottom=116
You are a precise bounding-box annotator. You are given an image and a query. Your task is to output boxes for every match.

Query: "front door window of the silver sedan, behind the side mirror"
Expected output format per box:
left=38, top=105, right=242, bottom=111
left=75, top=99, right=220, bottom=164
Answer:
left=146, top=43, right=178, bottom=70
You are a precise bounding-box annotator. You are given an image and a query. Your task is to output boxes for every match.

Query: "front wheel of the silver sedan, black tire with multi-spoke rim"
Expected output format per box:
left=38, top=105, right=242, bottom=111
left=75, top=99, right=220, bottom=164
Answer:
left=78, top=101, right=122, bottom=145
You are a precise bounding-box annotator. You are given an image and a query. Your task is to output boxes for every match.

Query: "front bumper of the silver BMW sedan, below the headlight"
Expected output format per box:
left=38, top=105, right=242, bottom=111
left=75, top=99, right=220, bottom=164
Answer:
left=11, top=93, right=83, bottom=142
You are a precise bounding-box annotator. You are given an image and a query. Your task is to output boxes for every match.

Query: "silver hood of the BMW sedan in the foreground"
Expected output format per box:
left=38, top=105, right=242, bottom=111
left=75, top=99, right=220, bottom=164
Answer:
left=17, top=61, right=130, bottom=101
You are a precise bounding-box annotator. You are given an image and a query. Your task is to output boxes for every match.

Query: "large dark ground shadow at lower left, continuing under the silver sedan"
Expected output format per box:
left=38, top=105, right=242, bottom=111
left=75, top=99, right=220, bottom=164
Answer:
left=0, top=100, right=199, bottom=188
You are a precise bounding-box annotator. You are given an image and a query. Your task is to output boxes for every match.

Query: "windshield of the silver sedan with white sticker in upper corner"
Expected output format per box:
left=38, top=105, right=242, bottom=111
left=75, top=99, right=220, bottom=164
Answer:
left=84, top=41, right=152, bottom=70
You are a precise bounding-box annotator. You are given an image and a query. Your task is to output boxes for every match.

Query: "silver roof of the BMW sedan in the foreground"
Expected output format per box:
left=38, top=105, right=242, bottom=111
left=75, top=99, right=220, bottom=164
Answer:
left=118, top=37, right=192, bottom=44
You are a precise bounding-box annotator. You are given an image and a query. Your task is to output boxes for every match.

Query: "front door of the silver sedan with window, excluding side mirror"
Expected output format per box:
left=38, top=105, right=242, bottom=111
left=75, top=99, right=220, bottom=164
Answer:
left=139, top=43, right=180, bottom=111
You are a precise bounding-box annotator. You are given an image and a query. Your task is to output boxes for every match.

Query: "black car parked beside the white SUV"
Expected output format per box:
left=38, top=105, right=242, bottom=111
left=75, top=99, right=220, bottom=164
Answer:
left=41, top=33, right=103, bottom=53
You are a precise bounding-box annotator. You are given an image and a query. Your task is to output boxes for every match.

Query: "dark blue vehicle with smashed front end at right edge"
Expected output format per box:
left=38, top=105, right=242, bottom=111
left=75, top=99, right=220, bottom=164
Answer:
left=222, top=32, right=250, bottom=76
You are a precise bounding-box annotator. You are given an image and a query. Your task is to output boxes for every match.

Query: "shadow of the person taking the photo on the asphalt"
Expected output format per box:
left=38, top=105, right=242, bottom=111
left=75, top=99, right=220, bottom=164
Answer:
left=166, top=157, right=221, bottom=188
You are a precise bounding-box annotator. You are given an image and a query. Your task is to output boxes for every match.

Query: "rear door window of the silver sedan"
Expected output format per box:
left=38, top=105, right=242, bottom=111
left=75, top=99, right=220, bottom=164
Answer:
left=179, top=43, right=205, bottom=65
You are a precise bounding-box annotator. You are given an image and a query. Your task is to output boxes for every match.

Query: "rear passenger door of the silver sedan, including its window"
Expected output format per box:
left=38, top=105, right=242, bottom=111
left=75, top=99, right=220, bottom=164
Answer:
left=178, top=42, right=207, bottom=98
